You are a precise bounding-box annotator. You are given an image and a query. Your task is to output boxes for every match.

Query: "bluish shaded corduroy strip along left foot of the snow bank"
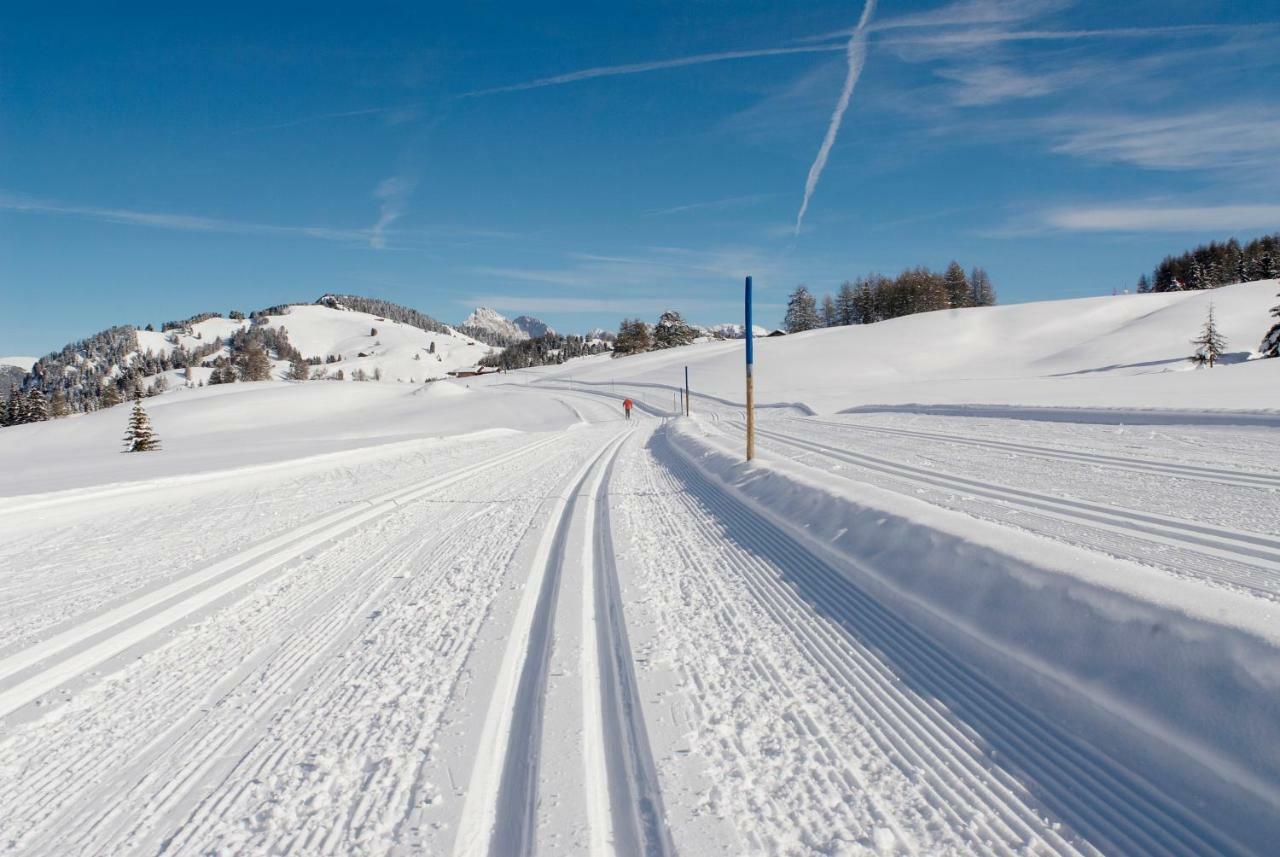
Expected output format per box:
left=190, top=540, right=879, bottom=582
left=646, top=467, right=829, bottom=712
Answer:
left=658, top=440, right=1251, bottom=857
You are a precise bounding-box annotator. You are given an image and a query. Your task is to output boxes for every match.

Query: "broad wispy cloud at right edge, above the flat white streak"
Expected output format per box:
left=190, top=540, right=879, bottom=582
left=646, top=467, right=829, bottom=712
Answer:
left=1047, top=105, right=1280, bottom=170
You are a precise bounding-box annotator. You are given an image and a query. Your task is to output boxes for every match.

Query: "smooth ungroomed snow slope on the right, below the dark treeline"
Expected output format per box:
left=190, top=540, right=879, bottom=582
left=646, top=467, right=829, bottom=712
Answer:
left=522, top=280, right=1280, bottom=413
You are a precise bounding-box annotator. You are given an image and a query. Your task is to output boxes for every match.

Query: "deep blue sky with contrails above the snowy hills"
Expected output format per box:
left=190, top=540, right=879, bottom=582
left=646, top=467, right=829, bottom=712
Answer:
left=0, top=0, right=1280, bottom=354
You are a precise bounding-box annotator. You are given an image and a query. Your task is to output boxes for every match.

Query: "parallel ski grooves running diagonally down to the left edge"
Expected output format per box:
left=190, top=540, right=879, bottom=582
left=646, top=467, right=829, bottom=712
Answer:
left=0, top=436, right=557, bottom=718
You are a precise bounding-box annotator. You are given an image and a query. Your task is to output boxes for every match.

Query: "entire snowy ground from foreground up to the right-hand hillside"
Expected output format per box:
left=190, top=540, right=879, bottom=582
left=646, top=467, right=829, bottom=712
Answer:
left=0, top=284, right=1280, bottom=856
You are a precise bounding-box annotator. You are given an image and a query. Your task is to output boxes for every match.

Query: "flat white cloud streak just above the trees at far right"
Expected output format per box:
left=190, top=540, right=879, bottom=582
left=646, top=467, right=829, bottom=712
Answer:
left=1043, top=205, right=1280, bottom=232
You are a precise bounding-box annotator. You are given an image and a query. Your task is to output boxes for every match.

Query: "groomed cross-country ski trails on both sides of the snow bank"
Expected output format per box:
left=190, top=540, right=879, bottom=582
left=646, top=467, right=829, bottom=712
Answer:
left=0, top=385, right=1280, bottom=857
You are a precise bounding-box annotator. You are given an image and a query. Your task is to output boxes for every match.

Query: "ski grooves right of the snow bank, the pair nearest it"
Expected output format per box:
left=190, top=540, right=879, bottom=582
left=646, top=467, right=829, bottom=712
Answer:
left=756, top=429, right=1280, bottom=597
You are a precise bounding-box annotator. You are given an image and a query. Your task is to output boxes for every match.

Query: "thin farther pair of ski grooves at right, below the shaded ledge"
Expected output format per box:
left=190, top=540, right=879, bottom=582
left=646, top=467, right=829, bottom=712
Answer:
left=797, top=418, right=1280, bottom=489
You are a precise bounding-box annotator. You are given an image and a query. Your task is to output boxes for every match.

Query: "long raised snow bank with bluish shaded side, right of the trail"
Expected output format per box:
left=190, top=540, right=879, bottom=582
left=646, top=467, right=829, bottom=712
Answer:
left=659, top=420, right=1280, bottom=852
